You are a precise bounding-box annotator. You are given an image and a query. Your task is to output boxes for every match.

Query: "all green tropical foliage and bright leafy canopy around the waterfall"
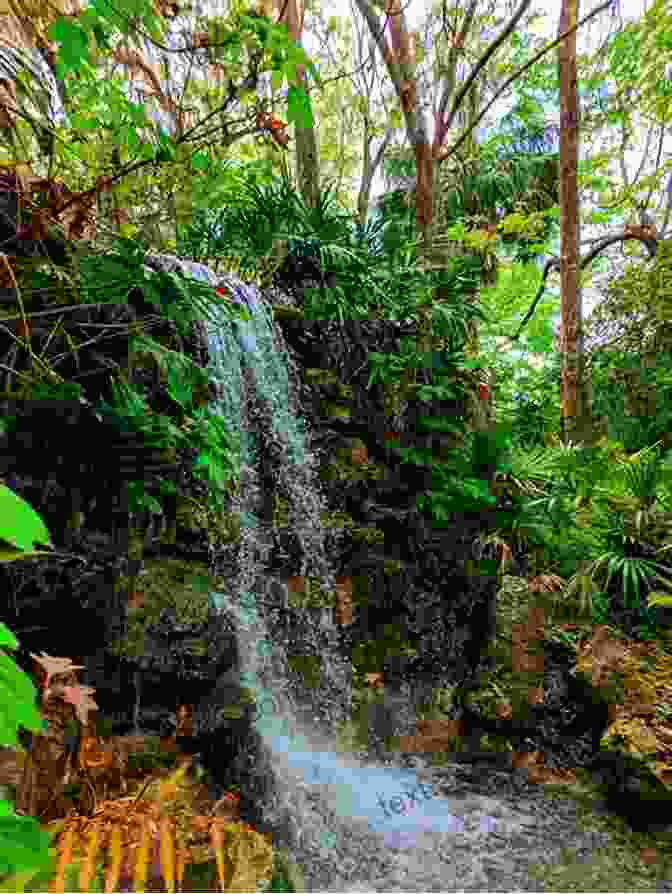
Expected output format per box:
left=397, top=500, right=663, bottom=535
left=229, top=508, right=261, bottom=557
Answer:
left=0, top=0, right=672, bottom=890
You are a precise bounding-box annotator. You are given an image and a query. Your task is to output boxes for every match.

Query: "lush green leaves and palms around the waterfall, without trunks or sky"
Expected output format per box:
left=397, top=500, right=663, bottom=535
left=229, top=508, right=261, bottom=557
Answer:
left=0, top=0, right=672, bottom=888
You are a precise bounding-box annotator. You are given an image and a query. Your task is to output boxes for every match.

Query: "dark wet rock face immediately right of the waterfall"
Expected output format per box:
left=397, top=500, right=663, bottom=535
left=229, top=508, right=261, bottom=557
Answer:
left=275, top=319, right=496, bottom=684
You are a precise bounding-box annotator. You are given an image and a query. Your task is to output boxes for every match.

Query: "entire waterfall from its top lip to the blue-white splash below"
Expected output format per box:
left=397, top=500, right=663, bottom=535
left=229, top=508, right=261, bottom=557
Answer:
left=176, top=265, right=506, bottom=890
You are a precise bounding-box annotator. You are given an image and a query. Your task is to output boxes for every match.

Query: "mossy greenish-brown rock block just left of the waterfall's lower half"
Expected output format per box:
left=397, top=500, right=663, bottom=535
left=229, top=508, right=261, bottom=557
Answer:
left=112, top=559, right=224, bottom=658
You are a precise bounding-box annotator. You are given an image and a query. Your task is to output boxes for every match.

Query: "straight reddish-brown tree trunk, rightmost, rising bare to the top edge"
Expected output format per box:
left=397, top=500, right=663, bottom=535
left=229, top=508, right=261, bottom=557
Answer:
left=558, top=0, right=590, bottom=442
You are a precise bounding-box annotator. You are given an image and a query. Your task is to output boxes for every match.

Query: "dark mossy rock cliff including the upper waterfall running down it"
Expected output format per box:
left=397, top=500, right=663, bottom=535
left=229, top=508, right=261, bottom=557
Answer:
left=0, top=256, right=502, bottom=837
